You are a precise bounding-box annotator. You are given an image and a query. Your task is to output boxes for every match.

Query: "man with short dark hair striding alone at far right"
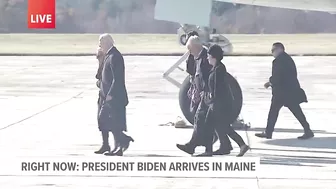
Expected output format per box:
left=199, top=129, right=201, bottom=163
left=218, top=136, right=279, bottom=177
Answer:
left=255, top=42, right=314, bottom=139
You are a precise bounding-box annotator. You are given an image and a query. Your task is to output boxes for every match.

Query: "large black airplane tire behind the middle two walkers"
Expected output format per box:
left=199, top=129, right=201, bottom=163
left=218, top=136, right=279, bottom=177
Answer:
left=179, top=73, right=243, bottom=124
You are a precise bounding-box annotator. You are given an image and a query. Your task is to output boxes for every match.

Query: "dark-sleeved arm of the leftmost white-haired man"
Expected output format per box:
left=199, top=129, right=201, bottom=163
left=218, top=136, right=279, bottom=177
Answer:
left=107, top=55, right=125, bottom=98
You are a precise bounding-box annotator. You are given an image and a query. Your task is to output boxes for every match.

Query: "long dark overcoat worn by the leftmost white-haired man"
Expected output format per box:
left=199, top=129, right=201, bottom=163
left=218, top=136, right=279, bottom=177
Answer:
left=98, top=47, right=128, bottom=131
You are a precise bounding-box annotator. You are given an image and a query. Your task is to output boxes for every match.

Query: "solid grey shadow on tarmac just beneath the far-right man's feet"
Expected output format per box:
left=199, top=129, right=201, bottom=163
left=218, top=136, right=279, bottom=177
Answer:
left=264, top=137, right=336, bottom=149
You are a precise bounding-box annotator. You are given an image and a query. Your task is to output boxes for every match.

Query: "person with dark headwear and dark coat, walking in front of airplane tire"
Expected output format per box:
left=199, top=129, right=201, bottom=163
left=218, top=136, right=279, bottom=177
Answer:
left=204, top=45, right=250, bottom=157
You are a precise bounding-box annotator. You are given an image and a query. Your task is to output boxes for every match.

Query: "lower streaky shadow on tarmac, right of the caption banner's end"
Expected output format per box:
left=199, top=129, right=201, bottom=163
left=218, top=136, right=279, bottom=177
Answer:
left=260, top=155, right=336, bottom=167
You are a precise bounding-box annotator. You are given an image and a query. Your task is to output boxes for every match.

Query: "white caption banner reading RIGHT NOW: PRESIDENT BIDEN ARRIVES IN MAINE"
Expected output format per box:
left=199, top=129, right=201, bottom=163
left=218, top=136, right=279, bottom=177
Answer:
left=0, top=156, right=260, bottom=178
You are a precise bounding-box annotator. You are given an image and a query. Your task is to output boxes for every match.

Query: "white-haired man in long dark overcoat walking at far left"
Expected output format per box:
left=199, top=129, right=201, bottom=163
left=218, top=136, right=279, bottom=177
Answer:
left=95, top=34, right=134, bottom=156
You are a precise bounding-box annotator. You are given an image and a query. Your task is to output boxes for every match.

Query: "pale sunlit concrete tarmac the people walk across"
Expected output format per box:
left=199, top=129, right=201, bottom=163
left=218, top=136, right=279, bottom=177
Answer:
left=0, top=56, right=336, bottom=189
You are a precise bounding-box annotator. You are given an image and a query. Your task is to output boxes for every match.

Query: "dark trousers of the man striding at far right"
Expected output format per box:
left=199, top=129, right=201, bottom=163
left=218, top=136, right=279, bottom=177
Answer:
left=266, top=97, right=311, bottom=135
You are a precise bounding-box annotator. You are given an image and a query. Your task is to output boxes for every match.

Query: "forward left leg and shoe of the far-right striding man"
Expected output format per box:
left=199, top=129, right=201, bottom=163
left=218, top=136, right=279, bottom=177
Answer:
left=255, top=98, right=283, bottom=139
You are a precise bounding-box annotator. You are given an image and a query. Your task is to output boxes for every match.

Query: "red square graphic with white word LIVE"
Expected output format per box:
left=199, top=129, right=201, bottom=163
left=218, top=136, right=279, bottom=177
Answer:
left=27, top=0, right=56, bottom=29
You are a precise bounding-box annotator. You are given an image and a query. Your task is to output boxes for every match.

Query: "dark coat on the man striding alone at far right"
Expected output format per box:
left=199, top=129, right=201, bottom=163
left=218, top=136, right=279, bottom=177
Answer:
left=269, top=52, right=308, bottom=107
